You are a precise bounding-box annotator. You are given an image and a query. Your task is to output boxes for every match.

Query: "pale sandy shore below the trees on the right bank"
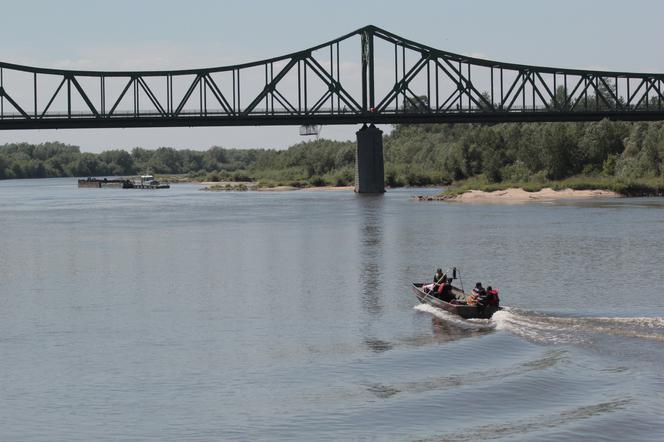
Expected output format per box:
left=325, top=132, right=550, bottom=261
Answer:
left=418, top=188, right=621, bottom=204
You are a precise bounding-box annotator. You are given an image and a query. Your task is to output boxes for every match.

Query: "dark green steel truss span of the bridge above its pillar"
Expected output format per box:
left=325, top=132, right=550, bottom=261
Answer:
left=0, top=26, right=664, bottom=129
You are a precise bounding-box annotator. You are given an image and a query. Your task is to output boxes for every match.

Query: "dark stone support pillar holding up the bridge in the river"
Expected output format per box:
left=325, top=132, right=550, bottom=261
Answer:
left=355, top=124, right=385, bottom=193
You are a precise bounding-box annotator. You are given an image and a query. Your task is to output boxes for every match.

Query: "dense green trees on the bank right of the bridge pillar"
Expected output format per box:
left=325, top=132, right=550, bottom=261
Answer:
left=385, top=120, right=664, bottom=185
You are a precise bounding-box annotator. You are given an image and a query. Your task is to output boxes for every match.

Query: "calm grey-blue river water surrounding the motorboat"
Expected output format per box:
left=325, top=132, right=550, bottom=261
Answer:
left=0, top=179, right=664, bottom=442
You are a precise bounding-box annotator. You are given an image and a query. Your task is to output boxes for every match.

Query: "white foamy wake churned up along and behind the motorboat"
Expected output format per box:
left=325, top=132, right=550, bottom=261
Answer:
left=415, top=304, right=664, bottom=344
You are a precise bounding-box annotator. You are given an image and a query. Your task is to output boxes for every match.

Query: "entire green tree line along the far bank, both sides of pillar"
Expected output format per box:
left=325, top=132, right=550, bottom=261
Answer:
left=0, top=120, right=664, bottom=186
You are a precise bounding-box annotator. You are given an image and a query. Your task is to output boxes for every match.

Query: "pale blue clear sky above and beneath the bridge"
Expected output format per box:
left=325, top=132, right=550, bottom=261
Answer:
left=0, top=0, right=664, bottom=152
